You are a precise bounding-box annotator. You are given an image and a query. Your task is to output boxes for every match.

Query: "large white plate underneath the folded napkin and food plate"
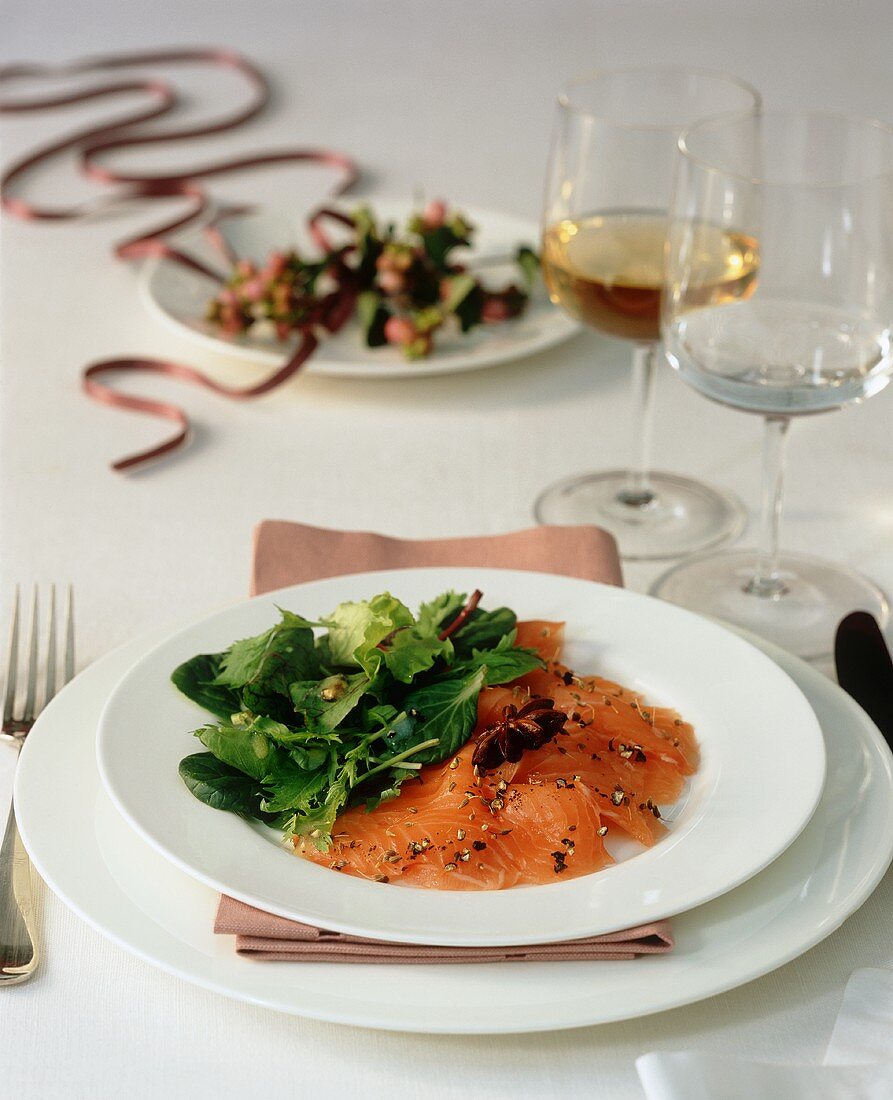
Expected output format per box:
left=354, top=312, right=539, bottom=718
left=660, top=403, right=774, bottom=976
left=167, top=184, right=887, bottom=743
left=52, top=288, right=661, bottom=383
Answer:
left=15, top=635, right=893, bottom=1034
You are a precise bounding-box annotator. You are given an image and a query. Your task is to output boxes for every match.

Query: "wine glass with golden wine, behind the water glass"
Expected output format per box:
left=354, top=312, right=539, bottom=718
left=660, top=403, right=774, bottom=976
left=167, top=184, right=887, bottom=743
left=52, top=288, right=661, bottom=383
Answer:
left=534, top=68, right=759, bottom=559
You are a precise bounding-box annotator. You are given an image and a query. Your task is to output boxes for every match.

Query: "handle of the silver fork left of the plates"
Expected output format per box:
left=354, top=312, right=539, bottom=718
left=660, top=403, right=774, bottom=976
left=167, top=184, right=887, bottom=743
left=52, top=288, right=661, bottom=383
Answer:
left=0, top=803, right=37, bottom=985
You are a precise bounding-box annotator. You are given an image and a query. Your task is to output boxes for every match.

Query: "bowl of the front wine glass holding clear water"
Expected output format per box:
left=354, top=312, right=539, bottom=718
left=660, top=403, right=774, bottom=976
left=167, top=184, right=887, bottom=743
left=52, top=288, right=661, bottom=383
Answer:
left=665, top=112, right=893, bottom=416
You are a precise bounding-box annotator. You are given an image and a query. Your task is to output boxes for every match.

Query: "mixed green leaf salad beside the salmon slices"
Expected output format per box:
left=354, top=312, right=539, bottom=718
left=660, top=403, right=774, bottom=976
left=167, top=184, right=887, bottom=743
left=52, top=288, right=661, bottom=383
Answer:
left=173, top=592, right=543, bottom=850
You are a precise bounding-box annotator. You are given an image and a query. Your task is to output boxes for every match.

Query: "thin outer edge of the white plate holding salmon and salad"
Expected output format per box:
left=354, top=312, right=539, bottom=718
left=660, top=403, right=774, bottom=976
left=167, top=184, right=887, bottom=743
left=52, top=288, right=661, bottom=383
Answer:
left=96, top=567, right=827, bottom=946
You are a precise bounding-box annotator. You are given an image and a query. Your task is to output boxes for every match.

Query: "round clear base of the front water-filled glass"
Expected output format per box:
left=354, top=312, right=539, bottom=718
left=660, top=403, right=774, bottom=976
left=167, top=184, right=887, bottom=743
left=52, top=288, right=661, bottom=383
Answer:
left=650, top=550, right=890, bottom=660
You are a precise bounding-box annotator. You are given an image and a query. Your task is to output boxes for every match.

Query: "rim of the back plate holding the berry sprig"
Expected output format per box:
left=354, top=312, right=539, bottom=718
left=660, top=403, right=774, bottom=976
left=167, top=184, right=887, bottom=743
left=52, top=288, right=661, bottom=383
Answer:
left=137, top=196, right=583, bottom=382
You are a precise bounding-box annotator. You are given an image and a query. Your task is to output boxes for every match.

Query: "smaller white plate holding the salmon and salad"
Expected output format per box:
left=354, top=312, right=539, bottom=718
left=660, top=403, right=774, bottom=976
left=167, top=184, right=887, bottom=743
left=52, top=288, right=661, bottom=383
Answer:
left=98, top=569, right=825, bottom=945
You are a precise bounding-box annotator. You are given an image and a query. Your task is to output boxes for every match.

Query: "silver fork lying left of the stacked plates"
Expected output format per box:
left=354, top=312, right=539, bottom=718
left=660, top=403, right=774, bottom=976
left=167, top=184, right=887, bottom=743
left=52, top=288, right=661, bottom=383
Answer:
left=0, top=585, right=75, bottom=986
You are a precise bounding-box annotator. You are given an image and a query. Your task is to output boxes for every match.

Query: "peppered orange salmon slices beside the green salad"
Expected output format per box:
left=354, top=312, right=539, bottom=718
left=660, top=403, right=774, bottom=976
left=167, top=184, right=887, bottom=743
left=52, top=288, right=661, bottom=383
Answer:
left=296, top=622, right=697, bottom=890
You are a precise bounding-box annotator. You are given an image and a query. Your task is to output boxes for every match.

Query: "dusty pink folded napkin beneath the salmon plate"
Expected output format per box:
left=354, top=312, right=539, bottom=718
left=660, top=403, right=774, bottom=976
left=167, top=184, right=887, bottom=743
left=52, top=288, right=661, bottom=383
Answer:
left=214, top=519, right=673, bottom=963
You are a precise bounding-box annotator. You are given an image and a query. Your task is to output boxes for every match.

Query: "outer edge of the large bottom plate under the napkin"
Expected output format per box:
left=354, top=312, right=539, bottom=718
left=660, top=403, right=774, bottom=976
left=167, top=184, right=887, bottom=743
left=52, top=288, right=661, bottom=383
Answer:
left=15, top=630, right=893, bottom=1034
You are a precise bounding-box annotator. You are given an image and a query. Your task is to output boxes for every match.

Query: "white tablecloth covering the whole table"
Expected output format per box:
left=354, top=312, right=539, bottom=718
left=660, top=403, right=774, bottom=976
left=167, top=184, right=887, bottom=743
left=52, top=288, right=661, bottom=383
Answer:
left=0, top=0, right=893, bottom=1100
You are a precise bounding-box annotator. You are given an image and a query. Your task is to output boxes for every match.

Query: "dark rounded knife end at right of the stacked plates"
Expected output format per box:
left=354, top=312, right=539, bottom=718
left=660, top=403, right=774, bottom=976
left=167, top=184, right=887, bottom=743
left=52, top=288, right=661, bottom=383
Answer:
left=834, top=612, right=893, bottom=749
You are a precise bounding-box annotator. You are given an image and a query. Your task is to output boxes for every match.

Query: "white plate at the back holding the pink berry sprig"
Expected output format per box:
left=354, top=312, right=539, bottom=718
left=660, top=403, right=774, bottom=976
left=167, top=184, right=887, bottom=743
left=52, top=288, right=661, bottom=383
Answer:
left=140, top=199, right=580, bottom=378
